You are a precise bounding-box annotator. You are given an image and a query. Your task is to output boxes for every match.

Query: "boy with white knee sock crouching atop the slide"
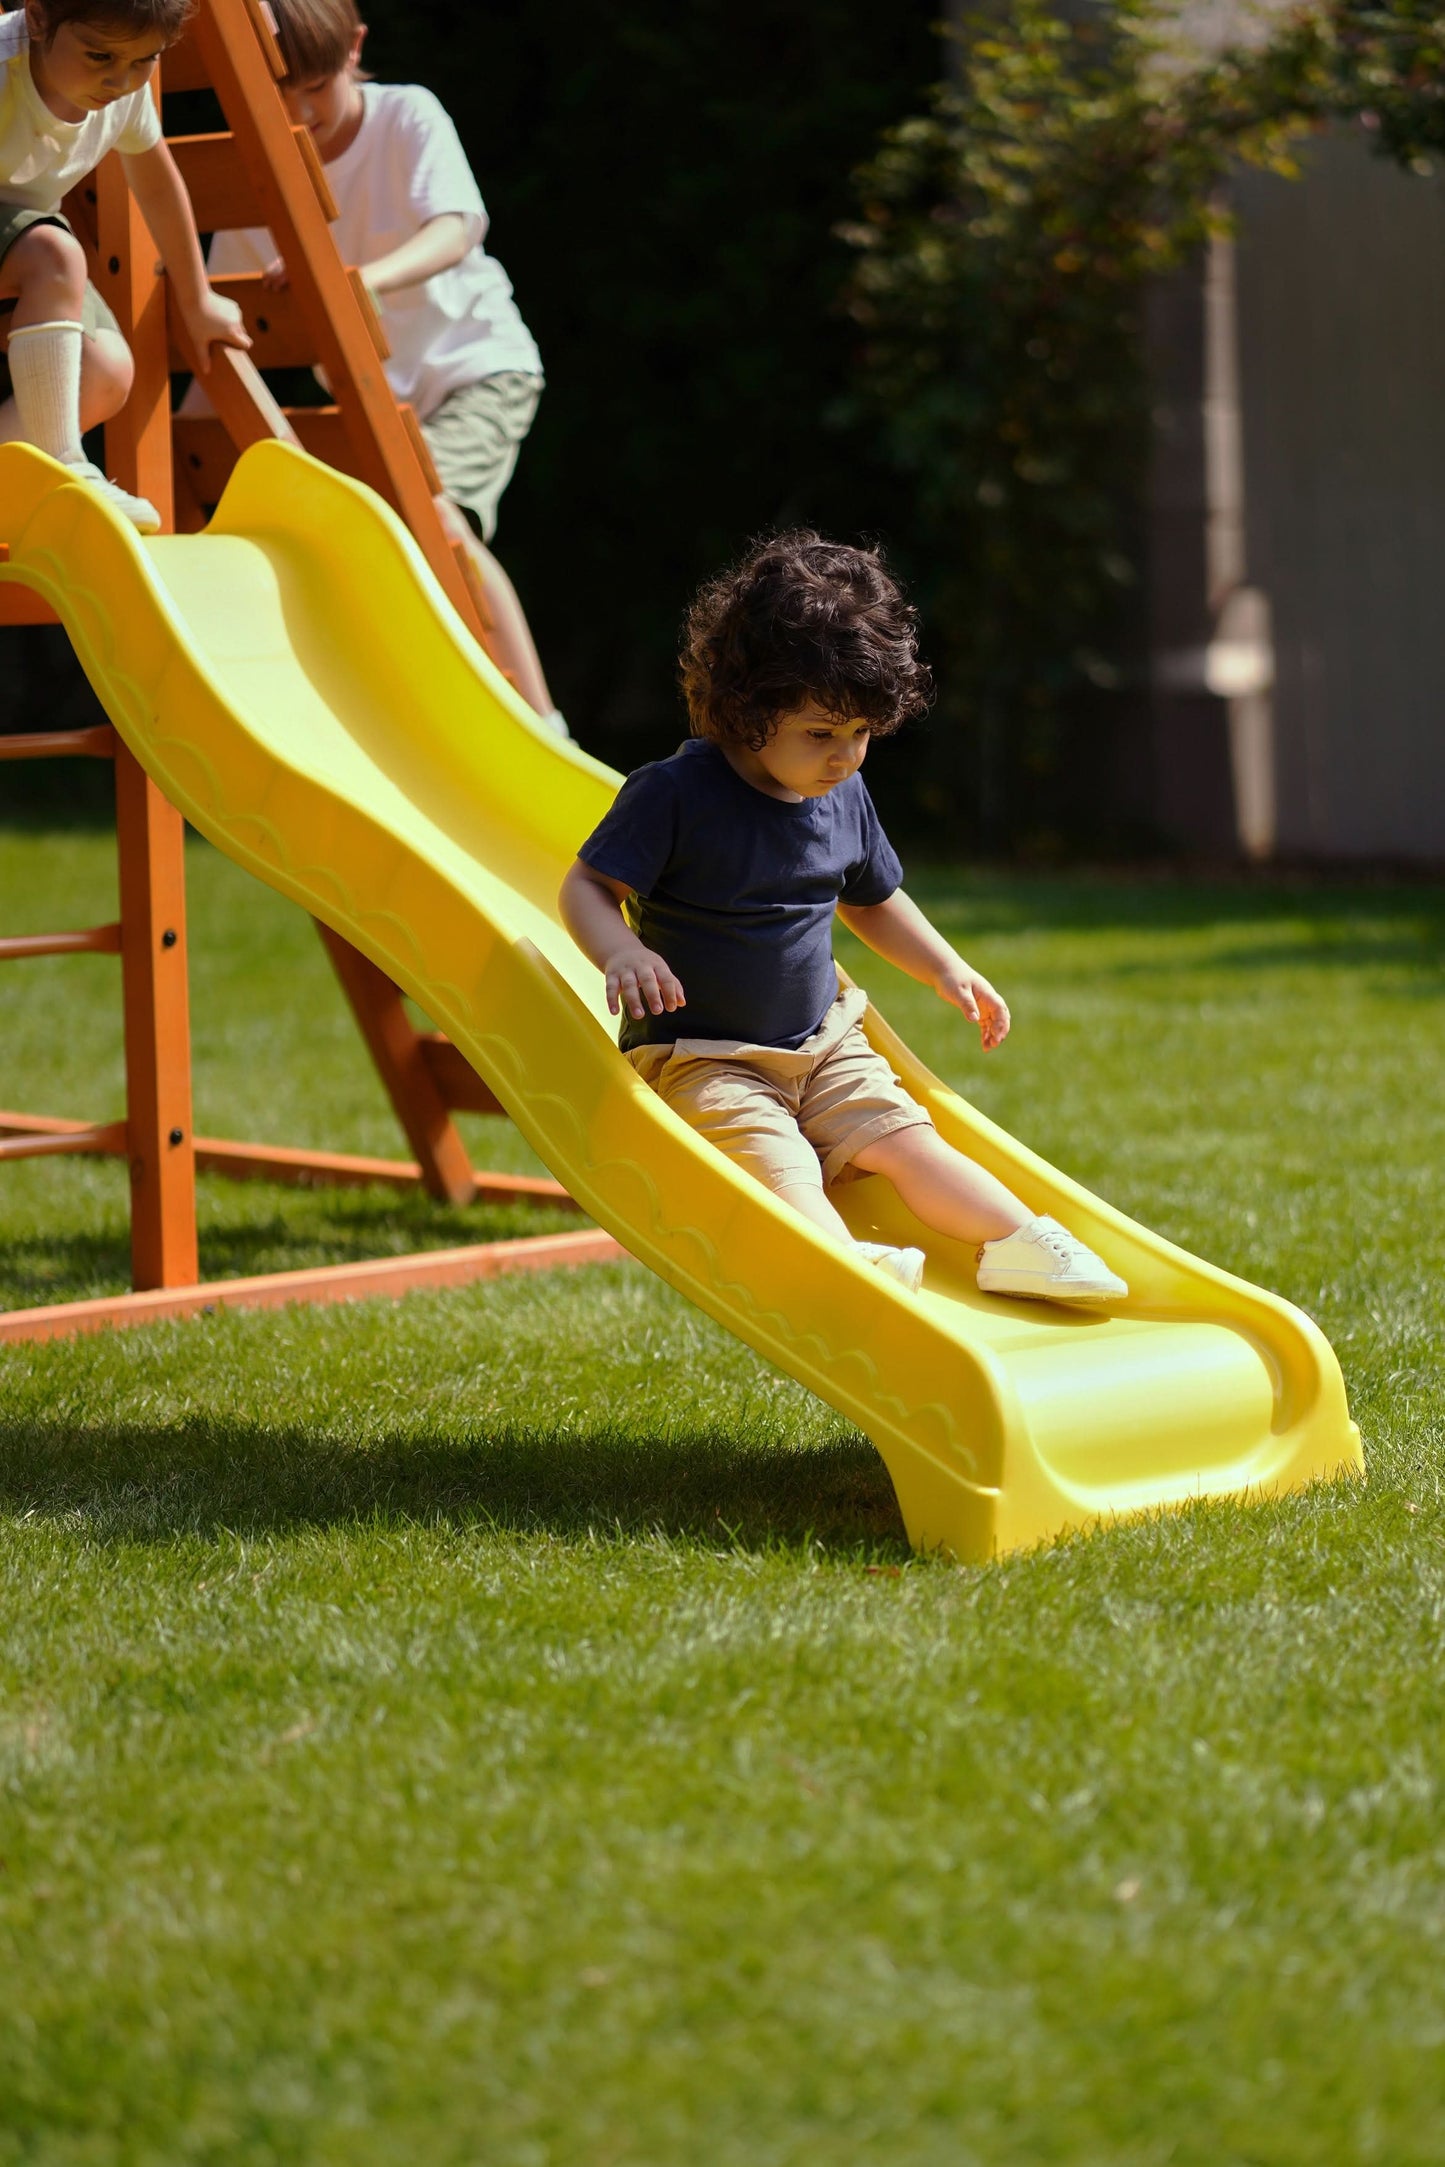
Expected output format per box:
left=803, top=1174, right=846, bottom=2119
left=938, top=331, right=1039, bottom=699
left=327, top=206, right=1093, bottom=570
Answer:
left=0, top=0, right=251, bottom=533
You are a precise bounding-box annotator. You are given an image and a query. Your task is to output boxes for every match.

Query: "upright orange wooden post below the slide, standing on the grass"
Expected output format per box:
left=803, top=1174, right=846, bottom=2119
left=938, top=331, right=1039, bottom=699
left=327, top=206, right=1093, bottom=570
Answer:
left=115, top=745, right=201, bottom=1289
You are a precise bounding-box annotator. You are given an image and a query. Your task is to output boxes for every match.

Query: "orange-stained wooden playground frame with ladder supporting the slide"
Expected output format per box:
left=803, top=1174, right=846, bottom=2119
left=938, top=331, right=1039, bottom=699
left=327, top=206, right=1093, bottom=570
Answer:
left=0, top=0, right=622, bottom=1344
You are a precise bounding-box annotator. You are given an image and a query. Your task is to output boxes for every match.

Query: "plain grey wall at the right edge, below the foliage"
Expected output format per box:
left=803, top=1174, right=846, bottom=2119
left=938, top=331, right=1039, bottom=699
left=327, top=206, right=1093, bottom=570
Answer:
left=1235, top=132, right=1445, bottom=860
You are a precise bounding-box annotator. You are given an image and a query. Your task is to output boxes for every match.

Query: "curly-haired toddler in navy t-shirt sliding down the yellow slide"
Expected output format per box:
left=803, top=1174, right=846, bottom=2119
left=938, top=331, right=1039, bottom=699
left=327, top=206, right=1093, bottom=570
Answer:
left=561, top=531, right=1129, bottom=1302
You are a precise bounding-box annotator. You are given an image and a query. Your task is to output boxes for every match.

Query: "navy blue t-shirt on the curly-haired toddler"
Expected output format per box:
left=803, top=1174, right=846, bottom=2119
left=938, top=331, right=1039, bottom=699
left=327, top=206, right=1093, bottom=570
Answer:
left=578, top=737, right=903, bottom=1053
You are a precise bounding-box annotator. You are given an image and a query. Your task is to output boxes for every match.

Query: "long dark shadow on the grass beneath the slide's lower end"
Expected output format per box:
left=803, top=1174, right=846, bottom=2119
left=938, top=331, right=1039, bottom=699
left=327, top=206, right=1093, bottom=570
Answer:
left=0, top=1422, right=908, bottom=1556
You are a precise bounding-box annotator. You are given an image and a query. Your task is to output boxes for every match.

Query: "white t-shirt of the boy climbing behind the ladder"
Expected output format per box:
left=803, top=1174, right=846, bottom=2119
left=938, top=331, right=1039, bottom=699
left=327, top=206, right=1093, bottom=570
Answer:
left=210, top=82, right=542, bottom=420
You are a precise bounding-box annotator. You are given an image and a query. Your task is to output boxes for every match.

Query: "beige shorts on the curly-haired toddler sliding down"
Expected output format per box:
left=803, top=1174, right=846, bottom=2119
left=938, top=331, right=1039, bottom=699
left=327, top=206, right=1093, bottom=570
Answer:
left=628, top=986, right=934, bottom=1190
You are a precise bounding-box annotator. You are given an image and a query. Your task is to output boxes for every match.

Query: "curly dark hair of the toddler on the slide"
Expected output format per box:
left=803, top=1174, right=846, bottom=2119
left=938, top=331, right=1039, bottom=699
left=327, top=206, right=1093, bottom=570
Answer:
left=680, top=527, right=934, bottom=752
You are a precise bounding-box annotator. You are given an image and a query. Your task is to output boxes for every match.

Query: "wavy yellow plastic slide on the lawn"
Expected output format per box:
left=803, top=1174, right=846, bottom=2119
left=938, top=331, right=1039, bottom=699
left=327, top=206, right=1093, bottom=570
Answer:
left=0, top=444, right=1363, bottom=1558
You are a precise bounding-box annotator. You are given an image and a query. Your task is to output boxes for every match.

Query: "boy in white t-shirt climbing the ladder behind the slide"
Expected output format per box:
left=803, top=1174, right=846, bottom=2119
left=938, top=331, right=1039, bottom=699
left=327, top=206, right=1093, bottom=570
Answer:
left=193, top=0, right=565, bottom=735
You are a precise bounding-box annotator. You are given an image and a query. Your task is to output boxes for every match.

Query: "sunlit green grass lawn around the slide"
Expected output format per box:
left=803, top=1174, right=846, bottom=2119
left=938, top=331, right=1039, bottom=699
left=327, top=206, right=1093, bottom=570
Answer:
left=0, top=830, right=1445, bottom=2167
